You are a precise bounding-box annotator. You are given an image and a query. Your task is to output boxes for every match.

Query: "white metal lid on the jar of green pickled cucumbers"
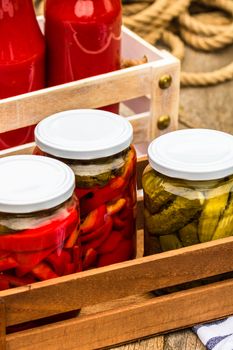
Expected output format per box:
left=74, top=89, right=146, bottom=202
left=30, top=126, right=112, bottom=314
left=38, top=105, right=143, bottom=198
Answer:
left=148, top=129, right=233, bottom=180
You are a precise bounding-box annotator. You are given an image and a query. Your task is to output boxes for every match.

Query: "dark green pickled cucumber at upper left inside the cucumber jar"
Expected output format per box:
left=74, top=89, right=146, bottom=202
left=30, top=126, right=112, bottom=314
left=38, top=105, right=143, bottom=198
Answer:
left=142, top=170, right=175, bottom=214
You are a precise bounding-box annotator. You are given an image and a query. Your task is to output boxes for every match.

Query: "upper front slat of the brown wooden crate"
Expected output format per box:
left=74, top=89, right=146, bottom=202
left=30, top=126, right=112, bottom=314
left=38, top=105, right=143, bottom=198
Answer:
left=0, top=237, right=233, bottom=325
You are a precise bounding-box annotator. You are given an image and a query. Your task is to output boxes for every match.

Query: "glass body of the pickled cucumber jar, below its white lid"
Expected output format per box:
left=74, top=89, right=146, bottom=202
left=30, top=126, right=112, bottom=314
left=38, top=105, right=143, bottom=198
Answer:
left=142, top=166, right=233, bottom=255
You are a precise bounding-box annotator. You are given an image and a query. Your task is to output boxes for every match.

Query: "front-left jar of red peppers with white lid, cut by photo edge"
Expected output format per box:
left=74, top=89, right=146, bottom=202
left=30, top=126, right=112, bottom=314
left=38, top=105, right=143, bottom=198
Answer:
left=0, top=155, right=82, bottom=290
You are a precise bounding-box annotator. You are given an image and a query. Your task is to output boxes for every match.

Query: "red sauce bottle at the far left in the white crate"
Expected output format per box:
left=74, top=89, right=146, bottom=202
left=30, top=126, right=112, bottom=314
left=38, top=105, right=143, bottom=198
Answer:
left=0, top=0, right=45, bottom=150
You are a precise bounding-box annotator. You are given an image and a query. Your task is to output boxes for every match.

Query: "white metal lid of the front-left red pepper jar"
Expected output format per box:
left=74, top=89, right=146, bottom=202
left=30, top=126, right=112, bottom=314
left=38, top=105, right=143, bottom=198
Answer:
left=0, top=155, right=75, bottom=213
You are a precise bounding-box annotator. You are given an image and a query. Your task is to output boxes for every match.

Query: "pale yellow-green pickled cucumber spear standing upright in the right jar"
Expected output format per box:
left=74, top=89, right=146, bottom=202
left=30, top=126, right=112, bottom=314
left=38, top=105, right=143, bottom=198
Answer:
left=198, top=182, right=233, bottom=242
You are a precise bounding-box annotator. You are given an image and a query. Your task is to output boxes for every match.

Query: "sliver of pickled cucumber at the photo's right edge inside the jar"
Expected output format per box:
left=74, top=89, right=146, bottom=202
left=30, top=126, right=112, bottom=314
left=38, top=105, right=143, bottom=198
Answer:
left=212, top=193, right=233, bottom=240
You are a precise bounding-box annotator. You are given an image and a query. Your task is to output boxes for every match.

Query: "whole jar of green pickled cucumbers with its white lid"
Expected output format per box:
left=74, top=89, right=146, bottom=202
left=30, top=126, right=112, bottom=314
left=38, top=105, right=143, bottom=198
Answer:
left=142, top=129, right=233, bottom=255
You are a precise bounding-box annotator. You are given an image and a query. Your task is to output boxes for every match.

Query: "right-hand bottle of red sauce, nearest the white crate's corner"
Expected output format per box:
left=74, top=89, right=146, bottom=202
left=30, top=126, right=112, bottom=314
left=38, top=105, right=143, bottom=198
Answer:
left=45, top=0, right=122, bottom=113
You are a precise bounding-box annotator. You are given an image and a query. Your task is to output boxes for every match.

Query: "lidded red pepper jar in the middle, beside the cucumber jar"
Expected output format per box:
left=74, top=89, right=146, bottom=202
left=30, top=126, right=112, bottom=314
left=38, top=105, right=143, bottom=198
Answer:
left=35, top=110, right=136, bottom=269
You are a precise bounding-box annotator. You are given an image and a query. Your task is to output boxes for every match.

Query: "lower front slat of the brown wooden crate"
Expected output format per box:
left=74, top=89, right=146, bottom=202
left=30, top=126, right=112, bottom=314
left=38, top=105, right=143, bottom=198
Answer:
left=6, top=280, right=233, bottom=350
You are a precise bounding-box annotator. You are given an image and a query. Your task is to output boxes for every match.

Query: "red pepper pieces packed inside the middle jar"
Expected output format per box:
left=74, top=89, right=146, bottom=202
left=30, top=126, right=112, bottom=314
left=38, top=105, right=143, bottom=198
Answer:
left=73, top=148, right=136, bottom=270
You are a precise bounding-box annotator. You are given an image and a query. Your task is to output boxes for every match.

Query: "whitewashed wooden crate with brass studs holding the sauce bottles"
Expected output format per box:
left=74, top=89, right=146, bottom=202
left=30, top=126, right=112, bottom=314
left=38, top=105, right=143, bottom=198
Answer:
left=0, top=17, right=180, bottom=156
